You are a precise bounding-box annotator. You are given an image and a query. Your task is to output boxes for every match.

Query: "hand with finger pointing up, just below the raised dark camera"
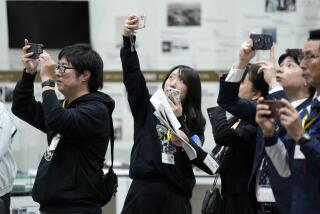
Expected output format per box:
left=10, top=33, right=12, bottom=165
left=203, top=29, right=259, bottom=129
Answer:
left=257, top=46, right=278, bottom=88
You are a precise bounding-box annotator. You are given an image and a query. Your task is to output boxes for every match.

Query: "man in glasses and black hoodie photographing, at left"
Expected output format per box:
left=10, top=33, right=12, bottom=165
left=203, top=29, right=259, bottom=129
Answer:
left=12, top=40, right=114, bottom=214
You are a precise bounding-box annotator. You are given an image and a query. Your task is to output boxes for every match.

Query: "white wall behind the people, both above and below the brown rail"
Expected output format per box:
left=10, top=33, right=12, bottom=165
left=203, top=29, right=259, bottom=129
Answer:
left=0, top=0, right=320, bottom=170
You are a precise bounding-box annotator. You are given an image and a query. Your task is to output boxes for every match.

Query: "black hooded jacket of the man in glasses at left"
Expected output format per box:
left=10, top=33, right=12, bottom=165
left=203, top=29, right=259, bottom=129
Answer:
left=12, top=72, right=114, bottom=213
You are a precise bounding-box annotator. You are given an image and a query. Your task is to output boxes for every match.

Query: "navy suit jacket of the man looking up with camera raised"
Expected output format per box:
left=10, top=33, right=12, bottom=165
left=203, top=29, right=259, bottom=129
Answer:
left=218, top=76, right=292, bottom=214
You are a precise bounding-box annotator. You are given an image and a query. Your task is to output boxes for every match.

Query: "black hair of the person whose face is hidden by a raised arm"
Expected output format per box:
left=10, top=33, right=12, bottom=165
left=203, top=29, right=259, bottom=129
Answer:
left=241, top=63, right=269, bottom=97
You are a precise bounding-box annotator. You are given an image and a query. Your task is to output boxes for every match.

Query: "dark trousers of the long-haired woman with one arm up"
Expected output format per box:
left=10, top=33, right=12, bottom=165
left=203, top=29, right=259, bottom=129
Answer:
left=121, top=180, right=192, bottom=214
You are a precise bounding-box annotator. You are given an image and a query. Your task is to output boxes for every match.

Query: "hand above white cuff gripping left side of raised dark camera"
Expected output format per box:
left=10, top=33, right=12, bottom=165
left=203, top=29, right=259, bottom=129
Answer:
left=234, top=39, right=256, bottom=69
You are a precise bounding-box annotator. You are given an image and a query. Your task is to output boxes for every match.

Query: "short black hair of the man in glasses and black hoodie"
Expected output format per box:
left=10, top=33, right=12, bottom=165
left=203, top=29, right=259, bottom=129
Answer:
left=58, top=44, right=103, bottom=92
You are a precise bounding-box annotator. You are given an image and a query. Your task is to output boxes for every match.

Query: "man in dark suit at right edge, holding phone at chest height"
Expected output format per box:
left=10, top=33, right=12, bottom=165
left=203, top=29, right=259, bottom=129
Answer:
left=256, top=30, right=320, bottom=214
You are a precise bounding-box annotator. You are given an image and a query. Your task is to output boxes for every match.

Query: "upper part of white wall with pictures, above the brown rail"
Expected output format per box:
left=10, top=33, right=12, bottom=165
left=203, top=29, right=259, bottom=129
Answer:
left=0, top=0, right=320, bottom=70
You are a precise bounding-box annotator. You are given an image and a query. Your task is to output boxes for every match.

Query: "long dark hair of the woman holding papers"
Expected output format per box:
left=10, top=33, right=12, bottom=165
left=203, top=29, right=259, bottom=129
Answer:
left=162, top=65, right=206, bottom=136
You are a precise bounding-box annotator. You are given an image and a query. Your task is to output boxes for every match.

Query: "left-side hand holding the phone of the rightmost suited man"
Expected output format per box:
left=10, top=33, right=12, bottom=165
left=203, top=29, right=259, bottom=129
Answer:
left=256, top=97, right=275, bottom=137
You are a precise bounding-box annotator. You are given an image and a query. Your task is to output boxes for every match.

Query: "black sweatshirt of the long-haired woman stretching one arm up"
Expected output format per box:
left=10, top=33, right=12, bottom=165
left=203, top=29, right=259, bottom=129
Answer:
left=120, top=37, right=212, bottom=198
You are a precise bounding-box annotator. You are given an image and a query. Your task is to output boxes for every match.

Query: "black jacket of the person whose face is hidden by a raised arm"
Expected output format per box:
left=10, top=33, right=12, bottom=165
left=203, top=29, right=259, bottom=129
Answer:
left=208, top=107, right=257, bottom=214
